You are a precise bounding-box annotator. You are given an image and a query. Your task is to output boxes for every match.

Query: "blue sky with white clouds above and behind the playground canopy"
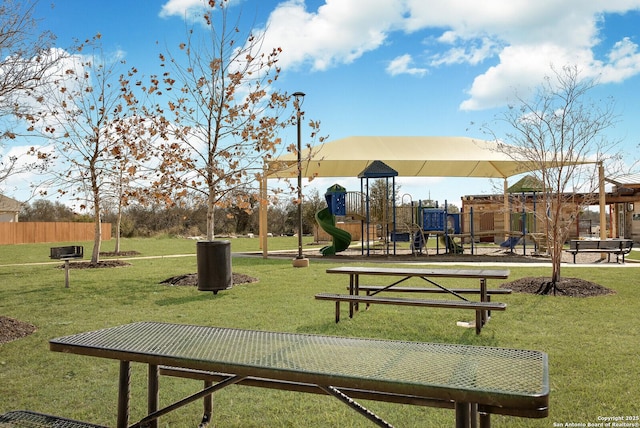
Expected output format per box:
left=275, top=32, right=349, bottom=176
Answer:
left=9, top=0, right=640, bottom=204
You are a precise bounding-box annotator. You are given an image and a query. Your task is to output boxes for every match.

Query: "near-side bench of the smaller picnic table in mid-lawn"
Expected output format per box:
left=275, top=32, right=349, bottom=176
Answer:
left=315, top=293, right=507, bottom=334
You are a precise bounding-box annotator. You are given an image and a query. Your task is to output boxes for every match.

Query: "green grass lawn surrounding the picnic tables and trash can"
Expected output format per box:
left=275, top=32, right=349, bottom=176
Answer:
left=0, top=238, right=640, bottom=427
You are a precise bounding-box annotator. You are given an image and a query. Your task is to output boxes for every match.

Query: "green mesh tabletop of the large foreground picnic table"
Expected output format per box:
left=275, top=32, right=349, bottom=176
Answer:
left=50, top=322, right=549, bottom=417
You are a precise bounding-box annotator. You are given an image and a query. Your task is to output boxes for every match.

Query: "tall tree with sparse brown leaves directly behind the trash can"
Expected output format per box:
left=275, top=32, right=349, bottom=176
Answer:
left=156, top=0, right=293, bottom=240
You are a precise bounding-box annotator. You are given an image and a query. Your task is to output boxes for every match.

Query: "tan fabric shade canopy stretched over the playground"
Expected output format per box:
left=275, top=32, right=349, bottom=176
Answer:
left=267, top=136, right=535, bottom=178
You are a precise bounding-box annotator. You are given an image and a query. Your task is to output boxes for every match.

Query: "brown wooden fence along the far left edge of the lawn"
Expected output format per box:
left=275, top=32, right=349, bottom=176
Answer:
left=0, top=222, right=111, bottom=245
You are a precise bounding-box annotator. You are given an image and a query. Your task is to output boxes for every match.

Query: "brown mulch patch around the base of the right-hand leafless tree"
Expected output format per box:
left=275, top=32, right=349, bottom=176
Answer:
left=500, top=276, right=615, bottom=297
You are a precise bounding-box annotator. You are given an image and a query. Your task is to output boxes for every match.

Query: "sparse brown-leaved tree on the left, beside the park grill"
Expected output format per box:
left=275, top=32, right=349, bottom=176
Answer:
left=21, top=35, right=155, bottom=263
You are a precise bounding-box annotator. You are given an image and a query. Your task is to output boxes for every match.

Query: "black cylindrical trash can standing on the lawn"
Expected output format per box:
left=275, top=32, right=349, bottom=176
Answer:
left=196, top=241, right=233, bottom=294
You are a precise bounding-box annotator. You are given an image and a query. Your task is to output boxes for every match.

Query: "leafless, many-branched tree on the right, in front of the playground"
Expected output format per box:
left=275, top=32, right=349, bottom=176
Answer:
left=490, top=66, right=618, bottom=294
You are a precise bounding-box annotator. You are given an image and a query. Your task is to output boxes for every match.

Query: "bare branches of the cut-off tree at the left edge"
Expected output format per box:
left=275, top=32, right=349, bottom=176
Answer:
left=0, top=0, right=65, bottom=194
